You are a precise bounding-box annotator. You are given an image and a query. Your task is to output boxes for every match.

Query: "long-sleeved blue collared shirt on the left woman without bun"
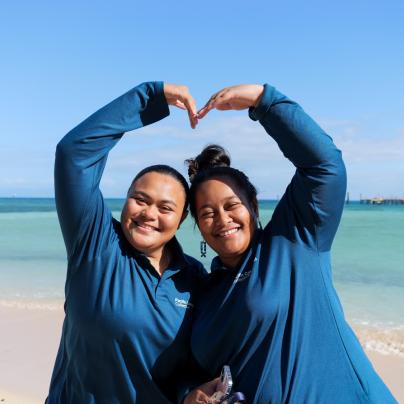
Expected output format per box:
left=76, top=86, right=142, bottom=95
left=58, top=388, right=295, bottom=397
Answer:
left=47, top=82, right=203, bottom=404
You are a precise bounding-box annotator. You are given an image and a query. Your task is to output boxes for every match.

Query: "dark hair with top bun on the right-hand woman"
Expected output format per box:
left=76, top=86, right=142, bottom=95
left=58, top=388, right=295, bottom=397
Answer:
left=185, top=144, right=258, bottom=221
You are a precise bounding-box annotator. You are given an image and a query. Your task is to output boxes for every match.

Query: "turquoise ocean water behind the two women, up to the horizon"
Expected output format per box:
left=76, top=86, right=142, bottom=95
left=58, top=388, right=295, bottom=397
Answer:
left=0, top=198, right=404, bottom=356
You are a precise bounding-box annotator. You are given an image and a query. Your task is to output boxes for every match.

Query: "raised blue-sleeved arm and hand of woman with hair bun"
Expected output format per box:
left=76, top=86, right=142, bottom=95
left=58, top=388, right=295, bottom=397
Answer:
left=199, top=84, right=346, bottom=251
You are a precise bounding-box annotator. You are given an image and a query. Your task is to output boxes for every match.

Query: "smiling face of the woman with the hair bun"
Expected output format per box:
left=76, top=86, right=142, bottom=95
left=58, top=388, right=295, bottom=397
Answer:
left=195, top=177, right=256, bottom=268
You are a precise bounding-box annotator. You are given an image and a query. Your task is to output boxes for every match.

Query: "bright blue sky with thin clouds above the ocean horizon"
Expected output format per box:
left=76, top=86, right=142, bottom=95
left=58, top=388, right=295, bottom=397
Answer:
left=0, top=0, right=404, bottom=198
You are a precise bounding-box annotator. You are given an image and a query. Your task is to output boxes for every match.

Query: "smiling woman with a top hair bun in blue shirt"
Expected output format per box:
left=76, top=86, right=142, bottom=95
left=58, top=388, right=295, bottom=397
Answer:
left=185, top=85, right=395, bottom=404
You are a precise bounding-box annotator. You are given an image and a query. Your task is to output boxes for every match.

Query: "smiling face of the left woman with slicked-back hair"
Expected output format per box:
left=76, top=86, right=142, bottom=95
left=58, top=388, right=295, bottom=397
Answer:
left=121, top=172, right=186, bottom=257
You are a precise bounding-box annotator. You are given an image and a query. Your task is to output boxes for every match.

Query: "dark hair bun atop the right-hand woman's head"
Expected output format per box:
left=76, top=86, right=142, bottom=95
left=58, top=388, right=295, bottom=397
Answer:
left=185, top=144, right=231, bottom=182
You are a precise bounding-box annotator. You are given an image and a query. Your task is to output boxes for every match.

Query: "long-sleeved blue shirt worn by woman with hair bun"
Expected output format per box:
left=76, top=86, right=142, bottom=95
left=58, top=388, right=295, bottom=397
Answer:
left=191, top=85, right=395, bottom=404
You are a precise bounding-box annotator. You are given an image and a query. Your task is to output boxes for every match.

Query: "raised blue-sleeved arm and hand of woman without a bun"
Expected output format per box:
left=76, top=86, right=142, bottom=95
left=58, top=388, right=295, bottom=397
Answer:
left=55, top=82, right=196, bottom=257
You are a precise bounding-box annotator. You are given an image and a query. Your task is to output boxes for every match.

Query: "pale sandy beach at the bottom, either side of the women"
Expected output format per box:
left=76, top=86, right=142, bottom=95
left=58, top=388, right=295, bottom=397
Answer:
left=0, top=306, right=404, bottom=404
